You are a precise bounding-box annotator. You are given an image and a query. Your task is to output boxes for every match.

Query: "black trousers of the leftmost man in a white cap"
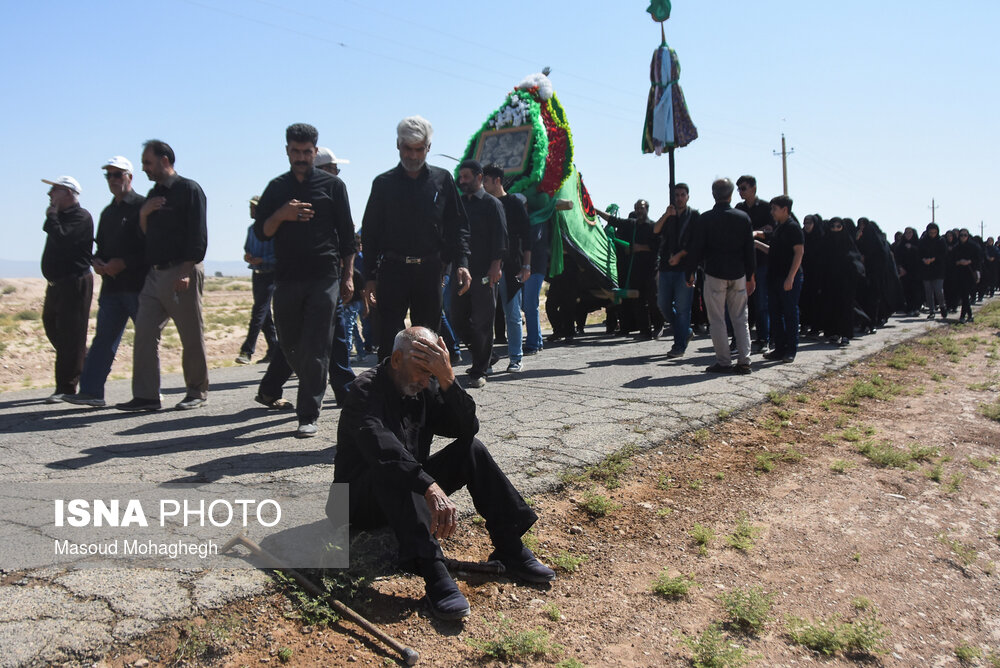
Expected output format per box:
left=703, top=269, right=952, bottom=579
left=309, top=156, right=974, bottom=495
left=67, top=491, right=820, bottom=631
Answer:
left=42, top=271, right=94, bottom=394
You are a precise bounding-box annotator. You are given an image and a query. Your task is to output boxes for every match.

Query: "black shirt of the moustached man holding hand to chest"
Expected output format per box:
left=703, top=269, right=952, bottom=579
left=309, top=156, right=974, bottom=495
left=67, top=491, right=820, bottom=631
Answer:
left=254, top=167, right=355, bottom=281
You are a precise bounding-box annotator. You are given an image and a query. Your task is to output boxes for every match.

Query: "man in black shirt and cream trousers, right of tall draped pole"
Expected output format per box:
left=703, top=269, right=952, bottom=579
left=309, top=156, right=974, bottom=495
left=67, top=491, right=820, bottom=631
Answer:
left=688, top=179, right=756, bottom=374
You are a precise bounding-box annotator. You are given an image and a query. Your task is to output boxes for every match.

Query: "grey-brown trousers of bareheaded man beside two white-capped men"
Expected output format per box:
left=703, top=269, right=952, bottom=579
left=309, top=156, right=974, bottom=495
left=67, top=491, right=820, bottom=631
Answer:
left=132, top=263, right=208, bottom=400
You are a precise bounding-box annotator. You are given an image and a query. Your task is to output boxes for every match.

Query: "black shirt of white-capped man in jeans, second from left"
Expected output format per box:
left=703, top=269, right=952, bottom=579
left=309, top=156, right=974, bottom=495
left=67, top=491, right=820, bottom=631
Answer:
left=94, top=190, right=149, bottom=294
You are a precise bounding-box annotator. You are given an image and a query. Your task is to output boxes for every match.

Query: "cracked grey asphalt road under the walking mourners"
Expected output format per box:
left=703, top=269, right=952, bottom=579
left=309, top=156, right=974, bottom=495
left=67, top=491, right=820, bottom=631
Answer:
left=0, top=318, right=952, bottom=666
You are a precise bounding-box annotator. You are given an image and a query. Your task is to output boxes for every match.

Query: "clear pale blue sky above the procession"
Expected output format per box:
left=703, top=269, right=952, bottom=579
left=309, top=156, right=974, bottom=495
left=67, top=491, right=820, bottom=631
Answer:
left=0, top=0, right=1000, bottom=274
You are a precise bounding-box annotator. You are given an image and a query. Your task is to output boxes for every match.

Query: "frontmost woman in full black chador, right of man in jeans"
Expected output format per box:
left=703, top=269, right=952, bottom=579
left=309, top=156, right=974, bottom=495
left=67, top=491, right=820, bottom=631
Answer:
left=821, top=218, right=865, bottom=346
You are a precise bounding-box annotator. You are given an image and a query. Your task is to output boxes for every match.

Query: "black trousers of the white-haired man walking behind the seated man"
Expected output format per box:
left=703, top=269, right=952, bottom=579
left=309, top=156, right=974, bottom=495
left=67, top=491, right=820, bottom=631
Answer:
left=375, top=258, right=444, bottom=361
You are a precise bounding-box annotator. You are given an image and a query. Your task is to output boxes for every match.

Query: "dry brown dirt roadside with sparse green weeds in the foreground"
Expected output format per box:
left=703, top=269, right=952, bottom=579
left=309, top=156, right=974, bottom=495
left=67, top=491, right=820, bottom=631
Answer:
left=90, top=303, right=1000, bottom=666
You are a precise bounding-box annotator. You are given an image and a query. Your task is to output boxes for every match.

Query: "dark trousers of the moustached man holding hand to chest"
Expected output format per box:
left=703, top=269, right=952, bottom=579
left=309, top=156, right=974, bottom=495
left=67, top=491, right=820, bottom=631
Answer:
left=272, top=276, right=340, bottom=424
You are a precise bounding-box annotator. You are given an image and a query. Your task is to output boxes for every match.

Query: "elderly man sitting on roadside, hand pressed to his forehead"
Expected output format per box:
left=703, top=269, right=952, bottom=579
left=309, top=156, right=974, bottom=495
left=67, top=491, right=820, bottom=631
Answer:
left=327, top=327, right=556, bottom=619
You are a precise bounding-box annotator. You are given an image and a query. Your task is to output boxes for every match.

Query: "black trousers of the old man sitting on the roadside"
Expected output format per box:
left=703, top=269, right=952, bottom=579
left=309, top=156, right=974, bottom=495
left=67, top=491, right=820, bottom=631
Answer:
left=327, top=438, right=538, bottom=563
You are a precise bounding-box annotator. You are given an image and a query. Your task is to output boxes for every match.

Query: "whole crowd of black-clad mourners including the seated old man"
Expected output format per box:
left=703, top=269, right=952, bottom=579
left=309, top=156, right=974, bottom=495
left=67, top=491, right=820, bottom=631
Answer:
left=35, top=116, right=1000, bottom=619
